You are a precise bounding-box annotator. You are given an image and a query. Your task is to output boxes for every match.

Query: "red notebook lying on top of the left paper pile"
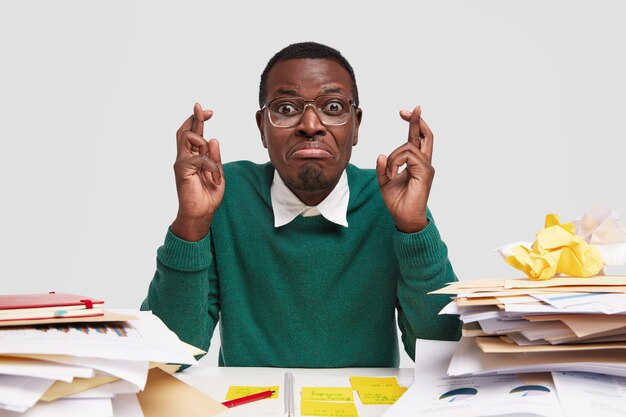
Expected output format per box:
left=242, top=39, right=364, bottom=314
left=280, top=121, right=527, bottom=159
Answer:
left=0, top=292, right=104, bottom=321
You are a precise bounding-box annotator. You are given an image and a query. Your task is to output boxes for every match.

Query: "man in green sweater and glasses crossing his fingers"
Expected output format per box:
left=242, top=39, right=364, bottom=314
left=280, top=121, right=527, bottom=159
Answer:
left=142, top=42, right=459, bottom=367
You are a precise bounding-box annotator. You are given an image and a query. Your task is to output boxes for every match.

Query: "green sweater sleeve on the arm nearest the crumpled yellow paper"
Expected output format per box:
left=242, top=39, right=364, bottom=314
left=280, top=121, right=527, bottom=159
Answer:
left=394, top=212, right=460, bottom=360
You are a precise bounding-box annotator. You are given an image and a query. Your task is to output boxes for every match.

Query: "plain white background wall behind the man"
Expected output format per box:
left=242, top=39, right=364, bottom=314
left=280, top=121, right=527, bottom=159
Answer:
left=0, top=0, right=626, bottom=365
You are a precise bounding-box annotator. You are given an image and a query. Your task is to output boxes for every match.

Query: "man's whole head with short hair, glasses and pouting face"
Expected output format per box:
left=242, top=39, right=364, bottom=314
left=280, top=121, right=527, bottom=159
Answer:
left=256, top=43, right=362, bottom=205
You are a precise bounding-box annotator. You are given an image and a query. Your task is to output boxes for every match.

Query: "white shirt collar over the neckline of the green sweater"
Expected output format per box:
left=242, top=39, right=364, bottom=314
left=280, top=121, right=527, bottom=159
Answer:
left=270, top=170, right=350, bottom=227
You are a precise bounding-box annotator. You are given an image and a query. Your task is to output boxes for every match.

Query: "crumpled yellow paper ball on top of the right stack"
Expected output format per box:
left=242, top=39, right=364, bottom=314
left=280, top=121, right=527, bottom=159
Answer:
left=504, top=214, right=604, bottom=280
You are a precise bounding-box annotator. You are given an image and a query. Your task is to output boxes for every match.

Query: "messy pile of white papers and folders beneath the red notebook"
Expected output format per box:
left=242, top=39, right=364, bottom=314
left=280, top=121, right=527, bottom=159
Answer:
left=0, top=297, right=214, bottom=417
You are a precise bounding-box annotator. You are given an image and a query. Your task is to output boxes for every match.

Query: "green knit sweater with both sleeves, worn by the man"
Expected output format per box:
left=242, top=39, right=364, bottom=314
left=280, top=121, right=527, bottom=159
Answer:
left=141, top=161, right=459, bottom=368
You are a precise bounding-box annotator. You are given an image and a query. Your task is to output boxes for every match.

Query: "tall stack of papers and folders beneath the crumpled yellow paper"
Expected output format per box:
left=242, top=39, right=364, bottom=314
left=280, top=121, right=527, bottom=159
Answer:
left=434, top=276, right=626, bottom=376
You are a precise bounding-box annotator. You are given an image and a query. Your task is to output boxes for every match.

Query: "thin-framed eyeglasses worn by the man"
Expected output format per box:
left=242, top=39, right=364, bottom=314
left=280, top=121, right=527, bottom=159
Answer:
left=261, top=94, right=356, bottom=127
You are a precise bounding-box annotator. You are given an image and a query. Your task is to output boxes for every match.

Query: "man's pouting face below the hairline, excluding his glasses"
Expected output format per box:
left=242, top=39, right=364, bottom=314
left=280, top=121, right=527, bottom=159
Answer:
left=257, top=59, right=361, bottom=204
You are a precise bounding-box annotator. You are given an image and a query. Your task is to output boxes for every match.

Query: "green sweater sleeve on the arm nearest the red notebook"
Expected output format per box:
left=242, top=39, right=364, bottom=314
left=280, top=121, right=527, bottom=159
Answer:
left=141, top=226, right=220, bottom=360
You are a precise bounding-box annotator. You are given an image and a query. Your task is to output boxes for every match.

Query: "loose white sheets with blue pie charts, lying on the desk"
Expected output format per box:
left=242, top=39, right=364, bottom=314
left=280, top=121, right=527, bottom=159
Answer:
left=384, top=339, right=626, bottom=417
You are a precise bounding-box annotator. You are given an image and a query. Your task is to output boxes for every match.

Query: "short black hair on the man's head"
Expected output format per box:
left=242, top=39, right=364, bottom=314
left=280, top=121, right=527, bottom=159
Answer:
left=259, top=42, right=359, bottom=108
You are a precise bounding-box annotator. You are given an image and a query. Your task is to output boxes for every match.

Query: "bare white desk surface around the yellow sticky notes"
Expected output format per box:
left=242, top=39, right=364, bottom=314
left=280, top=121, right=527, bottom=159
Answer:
left=178, top=365, right=414, bottom=417
